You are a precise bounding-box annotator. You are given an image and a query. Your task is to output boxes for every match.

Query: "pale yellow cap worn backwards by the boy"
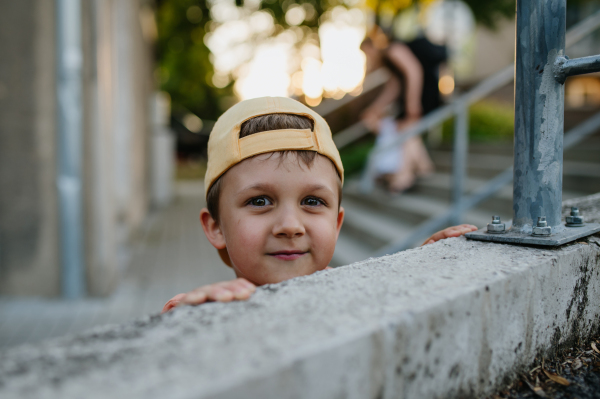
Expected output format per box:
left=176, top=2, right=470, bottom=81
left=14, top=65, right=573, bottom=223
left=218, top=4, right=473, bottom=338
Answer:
left=204, top=97, right=344, bottom=195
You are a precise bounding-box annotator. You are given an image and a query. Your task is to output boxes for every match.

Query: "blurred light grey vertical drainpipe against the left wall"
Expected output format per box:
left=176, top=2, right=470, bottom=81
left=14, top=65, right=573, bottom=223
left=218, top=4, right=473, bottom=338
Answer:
left=56, top=0, right=85, bottom=299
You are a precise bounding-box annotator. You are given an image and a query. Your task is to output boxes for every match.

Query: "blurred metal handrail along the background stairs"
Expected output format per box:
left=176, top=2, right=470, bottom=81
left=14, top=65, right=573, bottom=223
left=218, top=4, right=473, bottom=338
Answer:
left=319, top=12, right=600, bottom=256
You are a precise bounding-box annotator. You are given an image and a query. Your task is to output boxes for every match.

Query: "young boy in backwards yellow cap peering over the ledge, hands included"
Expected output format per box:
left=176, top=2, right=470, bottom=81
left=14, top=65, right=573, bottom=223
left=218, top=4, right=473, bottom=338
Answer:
left=163, top=97, right=477, bottom=312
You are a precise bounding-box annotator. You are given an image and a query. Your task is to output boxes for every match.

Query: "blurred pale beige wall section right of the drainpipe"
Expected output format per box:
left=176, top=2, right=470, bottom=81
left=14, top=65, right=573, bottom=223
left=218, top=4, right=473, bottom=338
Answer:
left=83, top=0, right=154, bottom=295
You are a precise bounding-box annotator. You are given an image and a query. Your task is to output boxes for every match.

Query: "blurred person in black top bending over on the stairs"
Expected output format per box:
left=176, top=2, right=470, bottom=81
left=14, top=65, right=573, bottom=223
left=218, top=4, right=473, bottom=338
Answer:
left=361, top=26, right=447, bottom=193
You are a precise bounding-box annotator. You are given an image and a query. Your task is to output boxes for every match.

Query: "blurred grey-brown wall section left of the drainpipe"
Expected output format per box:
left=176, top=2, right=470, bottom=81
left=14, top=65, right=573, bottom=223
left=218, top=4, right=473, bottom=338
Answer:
left=0, top=0, right=60, bottom=295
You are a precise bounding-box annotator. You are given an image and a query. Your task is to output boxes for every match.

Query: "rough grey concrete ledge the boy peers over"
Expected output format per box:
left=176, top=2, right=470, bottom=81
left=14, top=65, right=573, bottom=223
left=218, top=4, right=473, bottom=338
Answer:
left=0, top=195, right=600, bottom=399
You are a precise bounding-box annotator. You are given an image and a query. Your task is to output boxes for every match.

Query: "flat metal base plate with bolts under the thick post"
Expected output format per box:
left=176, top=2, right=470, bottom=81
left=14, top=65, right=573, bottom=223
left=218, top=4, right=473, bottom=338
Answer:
left=465, top=223, right=600, bottom=247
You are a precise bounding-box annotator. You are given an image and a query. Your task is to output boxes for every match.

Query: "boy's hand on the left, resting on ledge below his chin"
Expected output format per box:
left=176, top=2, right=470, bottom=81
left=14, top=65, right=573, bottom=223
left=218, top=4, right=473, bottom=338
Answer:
left=161, top=278, right=256, bottom=313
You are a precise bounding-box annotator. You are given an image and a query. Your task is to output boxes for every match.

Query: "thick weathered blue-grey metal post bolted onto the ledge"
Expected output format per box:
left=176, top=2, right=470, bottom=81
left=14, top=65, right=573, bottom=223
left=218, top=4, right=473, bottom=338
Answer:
left=512, top=0, right=566, bottom=234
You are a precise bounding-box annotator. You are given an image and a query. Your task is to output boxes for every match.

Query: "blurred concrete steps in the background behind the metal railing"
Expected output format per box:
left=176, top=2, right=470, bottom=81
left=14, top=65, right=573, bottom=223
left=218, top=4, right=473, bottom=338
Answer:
left=331, top=138, right=600, bottom=266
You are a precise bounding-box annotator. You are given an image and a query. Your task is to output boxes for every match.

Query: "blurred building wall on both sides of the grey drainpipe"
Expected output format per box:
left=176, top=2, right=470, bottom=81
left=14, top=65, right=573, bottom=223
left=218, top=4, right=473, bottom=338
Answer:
left=0, top=0, right=154, bottom=296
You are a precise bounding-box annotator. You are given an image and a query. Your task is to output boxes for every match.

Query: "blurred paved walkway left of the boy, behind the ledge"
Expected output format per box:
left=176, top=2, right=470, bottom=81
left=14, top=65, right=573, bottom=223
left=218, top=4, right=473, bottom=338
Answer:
left=0, top=183, right=235, bottom=349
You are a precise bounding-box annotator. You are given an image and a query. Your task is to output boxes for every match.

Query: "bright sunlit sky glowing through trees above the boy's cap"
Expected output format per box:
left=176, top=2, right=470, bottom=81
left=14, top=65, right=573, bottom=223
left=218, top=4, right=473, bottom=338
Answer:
left=205, top=0, right=366, bottom=106
